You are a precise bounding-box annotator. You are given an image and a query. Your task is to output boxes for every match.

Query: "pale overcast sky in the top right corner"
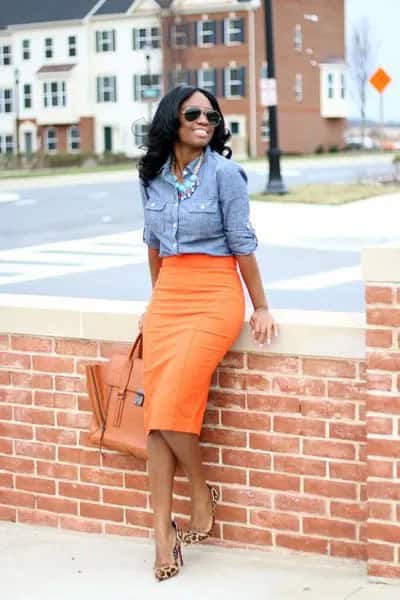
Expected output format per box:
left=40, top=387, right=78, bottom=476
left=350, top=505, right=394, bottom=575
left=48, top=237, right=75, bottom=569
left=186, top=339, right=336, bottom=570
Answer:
left=345, top=0, right=400, bottom=122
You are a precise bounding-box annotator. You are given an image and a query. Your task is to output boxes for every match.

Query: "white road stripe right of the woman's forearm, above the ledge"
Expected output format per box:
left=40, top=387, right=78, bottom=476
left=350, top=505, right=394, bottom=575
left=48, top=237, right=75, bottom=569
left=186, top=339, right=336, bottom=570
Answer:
left=265, top=265, right=362, bottom=290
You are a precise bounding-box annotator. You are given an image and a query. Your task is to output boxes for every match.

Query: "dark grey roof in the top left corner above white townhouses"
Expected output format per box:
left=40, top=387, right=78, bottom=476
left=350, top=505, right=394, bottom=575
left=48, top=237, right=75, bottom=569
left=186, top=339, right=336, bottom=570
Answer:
left=0, top=0, right=102, bottom=29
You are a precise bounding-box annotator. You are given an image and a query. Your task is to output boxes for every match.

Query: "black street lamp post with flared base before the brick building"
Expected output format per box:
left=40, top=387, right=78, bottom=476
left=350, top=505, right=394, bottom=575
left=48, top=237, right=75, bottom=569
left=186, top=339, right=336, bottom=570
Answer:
left=264, top=0, right=287, bottom=194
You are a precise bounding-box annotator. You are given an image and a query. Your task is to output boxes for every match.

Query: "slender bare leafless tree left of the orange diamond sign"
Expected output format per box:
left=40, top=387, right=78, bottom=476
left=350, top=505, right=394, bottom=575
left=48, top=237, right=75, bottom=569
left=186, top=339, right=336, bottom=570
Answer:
left=349, top=17, right=377, bottom=143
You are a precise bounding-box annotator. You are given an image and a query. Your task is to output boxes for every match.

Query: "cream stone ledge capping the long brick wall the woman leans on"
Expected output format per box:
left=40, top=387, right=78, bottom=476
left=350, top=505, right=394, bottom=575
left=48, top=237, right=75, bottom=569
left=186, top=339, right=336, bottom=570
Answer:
left=0, top=294, right=365, bottom=359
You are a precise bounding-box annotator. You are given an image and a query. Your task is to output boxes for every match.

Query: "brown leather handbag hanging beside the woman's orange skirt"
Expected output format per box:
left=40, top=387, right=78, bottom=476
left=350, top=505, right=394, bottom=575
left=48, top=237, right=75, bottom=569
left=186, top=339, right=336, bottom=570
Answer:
left=85, top=333, right=147, bottom=459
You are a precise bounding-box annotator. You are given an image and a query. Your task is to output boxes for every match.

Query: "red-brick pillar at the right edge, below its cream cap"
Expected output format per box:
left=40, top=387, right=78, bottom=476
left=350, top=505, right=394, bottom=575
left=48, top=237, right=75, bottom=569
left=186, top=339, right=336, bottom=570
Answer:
left=366, top=270, right=400, bottom=577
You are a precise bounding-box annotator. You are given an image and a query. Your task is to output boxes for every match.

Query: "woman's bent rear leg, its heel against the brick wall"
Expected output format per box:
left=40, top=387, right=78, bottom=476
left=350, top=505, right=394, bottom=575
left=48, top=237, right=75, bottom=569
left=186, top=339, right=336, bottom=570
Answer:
left=161, top=430, right=212, bottom=531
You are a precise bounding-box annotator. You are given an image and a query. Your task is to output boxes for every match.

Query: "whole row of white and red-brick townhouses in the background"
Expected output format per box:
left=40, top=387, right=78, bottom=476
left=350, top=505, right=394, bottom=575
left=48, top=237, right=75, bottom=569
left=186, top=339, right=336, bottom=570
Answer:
left=0, top=0, right=346, bottom=156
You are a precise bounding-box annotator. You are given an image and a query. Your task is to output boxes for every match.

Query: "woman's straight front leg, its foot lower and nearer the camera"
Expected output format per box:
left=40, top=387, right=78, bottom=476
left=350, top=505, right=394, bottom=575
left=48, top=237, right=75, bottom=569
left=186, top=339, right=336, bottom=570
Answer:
left=147, top=430, right=177, bottom=567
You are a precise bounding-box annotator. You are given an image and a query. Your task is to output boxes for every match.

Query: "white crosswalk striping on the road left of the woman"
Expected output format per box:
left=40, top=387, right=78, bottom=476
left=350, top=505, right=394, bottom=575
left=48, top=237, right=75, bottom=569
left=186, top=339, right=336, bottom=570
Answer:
left=0, top=229, right=147, bottom=286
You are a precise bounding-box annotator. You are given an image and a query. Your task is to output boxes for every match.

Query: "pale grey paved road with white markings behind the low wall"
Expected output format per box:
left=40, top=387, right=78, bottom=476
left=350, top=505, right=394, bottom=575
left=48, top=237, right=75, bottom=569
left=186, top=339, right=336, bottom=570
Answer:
left=0, top=157, right=393, bottom=312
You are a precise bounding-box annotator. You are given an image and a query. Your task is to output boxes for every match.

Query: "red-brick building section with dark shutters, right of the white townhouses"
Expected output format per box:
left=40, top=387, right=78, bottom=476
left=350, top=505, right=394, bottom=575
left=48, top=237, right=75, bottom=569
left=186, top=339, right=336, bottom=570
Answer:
left=162, top=0, right=346, bottom=156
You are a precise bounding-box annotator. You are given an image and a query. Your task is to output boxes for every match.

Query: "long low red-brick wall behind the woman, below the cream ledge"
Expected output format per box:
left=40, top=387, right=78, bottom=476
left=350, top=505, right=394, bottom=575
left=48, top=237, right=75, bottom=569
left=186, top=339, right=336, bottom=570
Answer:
left=0, top=335, right=366, bottom=559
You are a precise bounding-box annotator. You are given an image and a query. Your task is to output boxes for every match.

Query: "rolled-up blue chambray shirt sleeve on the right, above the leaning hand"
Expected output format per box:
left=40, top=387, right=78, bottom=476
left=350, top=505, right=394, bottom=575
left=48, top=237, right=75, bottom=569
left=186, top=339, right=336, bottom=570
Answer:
left=217, top=162, right=258, bottom=255
